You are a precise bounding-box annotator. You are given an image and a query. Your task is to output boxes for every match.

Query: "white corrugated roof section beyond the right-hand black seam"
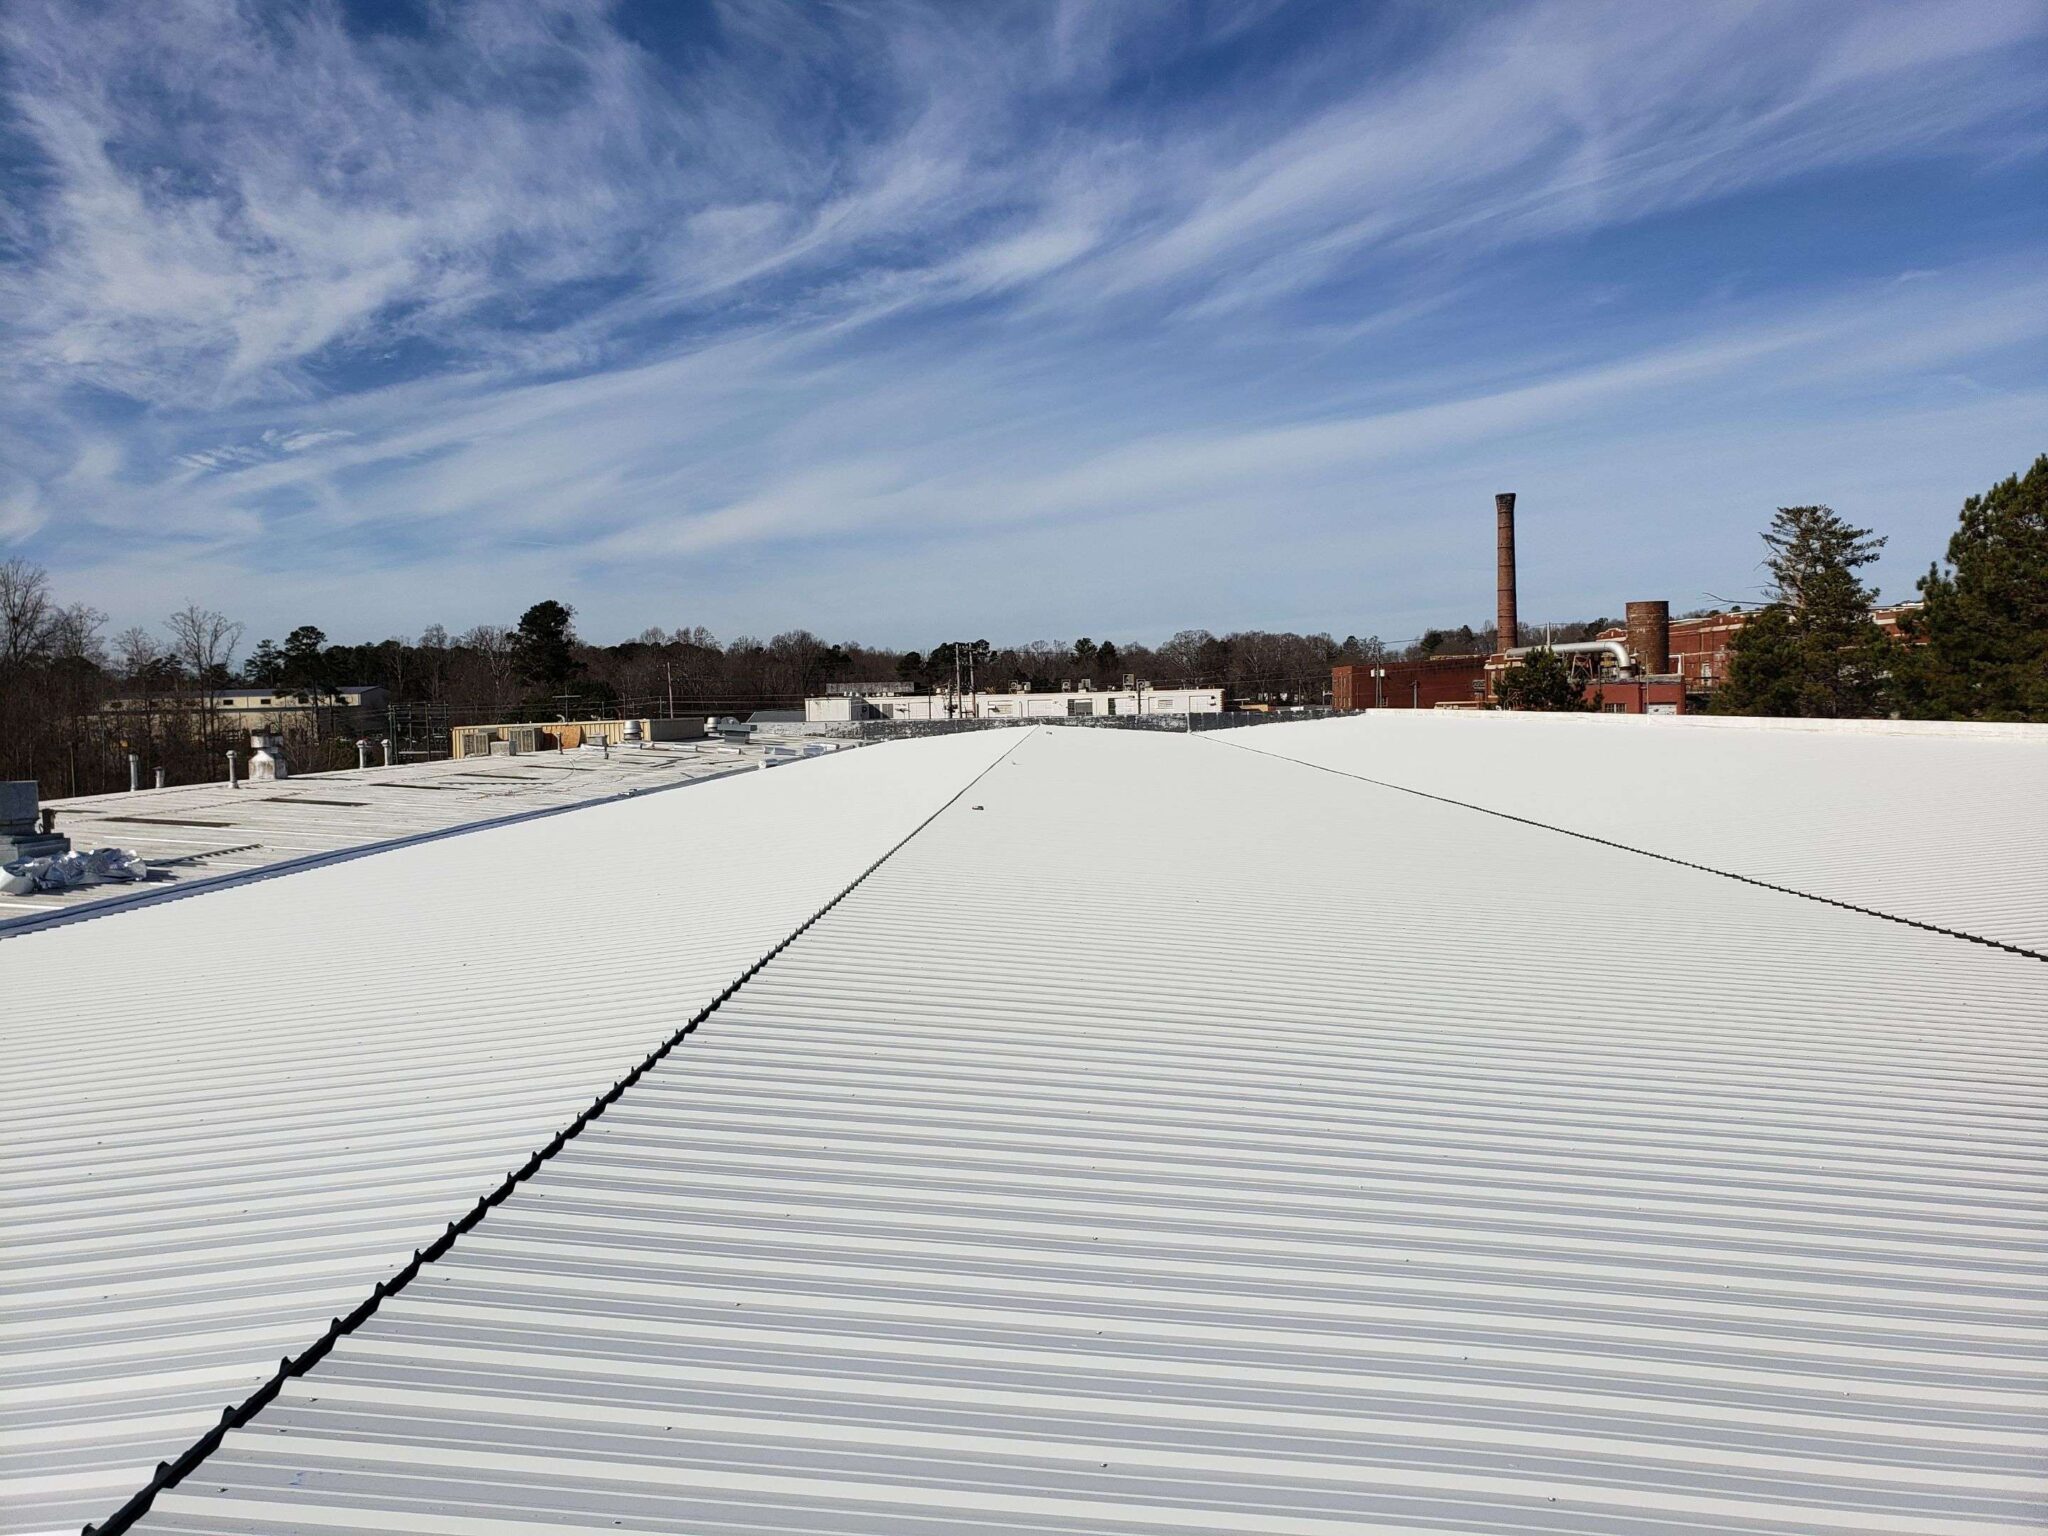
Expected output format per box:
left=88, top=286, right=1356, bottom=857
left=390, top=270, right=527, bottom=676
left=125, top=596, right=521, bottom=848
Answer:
left=1221, top=711, right=2048, bottom=954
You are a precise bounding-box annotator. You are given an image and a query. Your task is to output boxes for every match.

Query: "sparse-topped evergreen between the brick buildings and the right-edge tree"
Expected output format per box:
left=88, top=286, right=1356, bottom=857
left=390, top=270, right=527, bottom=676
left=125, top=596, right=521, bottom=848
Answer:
left=1714, top=506, right=1898, bottom=719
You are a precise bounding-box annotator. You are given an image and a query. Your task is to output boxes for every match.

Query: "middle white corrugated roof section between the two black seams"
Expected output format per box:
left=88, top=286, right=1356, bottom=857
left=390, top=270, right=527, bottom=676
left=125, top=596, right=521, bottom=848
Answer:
left=32, top=727, right=2048, bottom=1536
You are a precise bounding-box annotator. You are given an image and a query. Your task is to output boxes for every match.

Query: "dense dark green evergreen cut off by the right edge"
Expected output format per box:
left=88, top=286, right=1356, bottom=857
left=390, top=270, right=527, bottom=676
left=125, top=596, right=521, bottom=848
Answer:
left=1903, top=453, right=2048, bottom=721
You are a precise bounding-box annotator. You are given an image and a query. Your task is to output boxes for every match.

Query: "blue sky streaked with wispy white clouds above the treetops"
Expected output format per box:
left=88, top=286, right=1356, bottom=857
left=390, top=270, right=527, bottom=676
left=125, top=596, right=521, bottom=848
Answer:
left=0, top=0, right=2048, bottom=645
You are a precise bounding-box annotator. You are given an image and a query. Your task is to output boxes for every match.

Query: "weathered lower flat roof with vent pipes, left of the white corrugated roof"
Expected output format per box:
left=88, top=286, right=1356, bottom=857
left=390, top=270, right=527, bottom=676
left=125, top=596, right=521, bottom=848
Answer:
left=12, top=741, right=802, bottom=934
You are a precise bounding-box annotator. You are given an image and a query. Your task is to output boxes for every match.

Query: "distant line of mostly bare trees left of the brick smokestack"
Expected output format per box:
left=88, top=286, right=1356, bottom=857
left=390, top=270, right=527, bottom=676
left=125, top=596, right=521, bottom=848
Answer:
left=0, top=573, right=1441, bottom=795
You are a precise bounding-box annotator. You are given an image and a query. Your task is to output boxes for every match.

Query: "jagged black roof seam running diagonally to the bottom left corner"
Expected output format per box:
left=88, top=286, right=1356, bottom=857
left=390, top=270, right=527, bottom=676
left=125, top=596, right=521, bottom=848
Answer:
left=80, top=727, right=1036, bottom=1536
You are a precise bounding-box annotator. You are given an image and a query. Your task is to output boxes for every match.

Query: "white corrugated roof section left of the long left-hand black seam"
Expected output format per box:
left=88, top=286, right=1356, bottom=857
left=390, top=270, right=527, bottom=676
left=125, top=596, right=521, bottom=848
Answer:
left=0, top=735, right=1024, bottom=1530
